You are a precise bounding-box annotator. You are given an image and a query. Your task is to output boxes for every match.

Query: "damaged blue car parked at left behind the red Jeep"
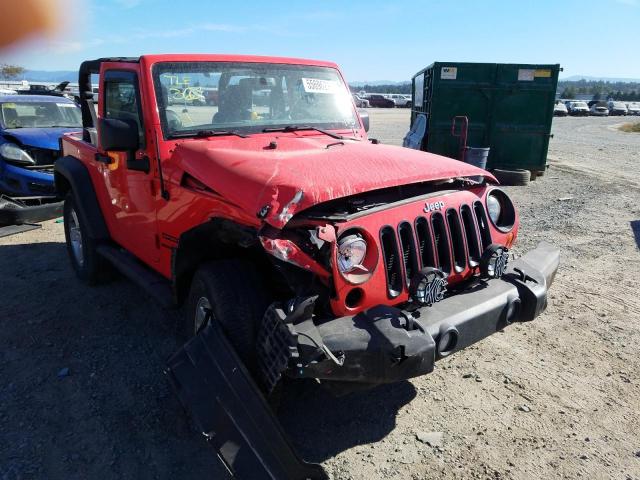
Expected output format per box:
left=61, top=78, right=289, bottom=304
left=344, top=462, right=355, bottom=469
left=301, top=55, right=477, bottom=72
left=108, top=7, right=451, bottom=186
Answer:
left=0, top=95, right=82, bottom=225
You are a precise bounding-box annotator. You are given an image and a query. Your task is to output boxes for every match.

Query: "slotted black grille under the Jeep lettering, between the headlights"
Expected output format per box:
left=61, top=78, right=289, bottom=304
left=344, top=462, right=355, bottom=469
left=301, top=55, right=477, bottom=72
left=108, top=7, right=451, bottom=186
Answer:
left=380, top=202, right=491, bottom=298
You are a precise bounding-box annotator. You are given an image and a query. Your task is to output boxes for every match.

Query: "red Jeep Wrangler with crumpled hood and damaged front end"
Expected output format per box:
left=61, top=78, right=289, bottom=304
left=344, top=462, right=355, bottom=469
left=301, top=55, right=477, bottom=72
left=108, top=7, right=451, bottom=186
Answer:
left=55, top=55, right=559, bottom=392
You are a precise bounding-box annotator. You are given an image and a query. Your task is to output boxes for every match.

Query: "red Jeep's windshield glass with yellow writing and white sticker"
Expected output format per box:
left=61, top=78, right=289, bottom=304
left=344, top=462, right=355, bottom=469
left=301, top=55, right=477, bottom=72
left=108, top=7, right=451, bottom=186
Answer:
left=154, top=62, right=359, bottom=137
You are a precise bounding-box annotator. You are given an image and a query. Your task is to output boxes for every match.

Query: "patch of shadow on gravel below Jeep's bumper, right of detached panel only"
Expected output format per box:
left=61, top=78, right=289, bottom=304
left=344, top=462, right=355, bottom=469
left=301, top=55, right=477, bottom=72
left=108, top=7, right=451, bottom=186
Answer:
left=278, top=381, right=416, bottom=463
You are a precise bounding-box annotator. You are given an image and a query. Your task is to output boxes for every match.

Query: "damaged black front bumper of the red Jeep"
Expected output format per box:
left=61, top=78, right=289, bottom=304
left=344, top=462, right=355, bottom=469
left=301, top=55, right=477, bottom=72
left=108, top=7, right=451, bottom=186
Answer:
left=258, top=243, right=560, bottom=389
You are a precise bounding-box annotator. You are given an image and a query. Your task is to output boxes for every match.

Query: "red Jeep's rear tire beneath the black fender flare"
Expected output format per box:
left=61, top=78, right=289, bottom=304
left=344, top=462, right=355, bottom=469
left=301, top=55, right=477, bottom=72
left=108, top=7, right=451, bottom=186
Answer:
left=63, top=191, right=112, bottom=285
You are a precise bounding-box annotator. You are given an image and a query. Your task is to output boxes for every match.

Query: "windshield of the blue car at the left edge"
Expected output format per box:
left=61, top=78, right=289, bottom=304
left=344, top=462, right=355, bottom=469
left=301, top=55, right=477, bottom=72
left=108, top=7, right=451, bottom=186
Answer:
left=0, top=101, right=82, bottom=128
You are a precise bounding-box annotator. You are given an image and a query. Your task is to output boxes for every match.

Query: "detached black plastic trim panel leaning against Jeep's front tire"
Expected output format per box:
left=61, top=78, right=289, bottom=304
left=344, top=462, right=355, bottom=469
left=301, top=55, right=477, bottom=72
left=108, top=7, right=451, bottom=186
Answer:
left=167, top=322, right=328, bottom=480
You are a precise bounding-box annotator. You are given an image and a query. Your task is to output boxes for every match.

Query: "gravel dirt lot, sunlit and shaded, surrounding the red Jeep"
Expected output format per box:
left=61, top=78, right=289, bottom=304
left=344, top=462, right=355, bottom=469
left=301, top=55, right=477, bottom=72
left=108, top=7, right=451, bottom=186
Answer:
left=0, top=109, right=640, bottom=480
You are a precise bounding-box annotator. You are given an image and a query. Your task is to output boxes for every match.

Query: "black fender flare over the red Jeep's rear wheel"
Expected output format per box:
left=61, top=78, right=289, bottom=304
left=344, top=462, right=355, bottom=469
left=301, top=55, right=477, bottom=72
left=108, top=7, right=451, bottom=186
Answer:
left=54, top=155, right=110, bottom=241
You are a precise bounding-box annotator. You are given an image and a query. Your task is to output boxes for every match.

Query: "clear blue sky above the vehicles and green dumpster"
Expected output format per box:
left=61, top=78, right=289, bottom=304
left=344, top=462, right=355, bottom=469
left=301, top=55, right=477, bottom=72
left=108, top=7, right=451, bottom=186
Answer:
left=0, top=0, right=640, bottom=82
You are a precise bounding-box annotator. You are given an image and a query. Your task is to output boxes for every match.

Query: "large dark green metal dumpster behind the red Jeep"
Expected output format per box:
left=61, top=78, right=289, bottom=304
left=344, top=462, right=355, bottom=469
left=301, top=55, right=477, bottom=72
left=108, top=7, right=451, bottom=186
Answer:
left=411, top=62, right=560, bottom=178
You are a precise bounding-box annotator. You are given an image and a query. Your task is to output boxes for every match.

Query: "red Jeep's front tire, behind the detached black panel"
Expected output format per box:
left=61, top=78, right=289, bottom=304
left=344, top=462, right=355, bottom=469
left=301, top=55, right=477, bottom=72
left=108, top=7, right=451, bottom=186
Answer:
left=183, top=259, right=269, bottom=371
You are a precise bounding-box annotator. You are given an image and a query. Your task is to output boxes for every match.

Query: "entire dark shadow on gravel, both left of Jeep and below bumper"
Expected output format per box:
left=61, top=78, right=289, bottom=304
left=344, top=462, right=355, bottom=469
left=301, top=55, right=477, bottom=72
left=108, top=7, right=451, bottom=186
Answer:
left=0, top=241, right=416, bottom=480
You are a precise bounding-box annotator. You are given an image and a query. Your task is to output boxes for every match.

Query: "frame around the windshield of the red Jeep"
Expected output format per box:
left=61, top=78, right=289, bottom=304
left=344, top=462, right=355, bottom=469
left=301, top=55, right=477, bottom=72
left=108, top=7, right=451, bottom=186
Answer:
left=151, top=60, right=363, bottom=140
